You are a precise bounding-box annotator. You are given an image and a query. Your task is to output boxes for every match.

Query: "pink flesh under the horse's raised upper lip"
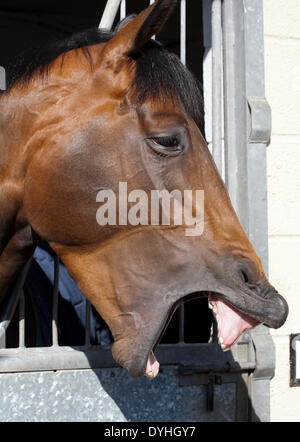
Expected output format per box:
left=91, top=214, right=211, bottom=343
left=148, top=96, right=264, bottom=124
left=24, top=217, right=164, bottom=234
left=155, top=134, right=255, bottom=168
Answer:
left=209, top=296, right=259, bottom=350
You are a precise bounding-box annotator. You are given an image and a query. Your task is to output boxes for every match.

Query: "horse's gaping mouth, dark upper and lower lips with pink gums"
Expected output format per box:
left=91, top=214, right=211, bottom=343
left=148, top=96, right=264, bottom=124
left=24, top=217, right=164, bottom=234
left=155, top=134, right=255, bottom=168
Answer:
left=118, top=281, right=288, bottom=378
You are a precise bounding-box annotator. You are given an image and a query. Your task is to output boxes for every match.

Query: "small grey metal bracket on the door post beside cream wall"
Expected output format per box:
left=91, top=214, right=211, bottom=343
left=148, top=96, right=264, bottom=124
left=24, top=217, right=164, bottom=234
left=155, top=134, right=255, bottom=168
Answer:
left=247, top=97, right=271, bottom=144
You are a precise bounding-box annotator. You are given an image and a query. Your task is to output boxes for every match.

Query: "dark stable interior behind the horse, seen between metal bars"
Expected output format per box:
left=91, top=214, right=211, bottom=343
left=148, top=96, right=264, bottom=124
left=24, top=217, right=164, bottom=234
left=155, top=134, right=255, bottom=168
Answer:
left=0, top=0, right=212, bottom=347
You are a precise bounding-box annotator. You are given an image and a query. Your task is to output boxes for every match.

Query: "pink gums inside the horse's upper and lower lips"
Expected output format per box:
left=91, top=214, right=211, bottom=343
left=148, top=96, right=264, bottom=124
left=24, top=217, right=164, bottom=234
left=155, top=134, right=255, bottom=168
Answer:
left=145, top=292, right=261, bottom=379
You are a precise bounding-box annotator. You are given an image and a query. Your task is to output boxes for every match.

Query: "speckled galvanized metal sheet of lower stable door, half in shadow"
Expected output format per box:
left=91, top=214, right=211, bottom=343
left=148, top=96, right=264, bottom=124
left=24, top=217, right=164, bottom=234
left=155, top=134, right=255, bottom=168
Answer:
left=0, top=367, right=236, bottom=422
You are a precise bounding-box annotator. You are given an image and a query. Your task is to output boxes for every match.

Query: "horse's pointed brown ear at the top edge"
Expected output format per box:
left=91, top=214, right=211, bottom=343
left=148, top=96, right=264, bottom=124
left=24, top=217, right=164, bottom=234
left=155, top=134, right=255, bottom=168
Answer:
left=104, top=0, right=178, bottom=59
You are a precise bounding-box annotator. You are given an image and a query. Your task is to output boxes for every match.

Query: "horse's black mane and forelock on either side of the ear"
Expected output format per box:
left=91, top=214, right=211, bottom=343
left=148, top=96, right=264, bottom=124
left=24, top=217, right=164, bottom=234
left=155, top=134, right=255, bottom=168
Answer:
left=7, top=24, right=204, bottom=133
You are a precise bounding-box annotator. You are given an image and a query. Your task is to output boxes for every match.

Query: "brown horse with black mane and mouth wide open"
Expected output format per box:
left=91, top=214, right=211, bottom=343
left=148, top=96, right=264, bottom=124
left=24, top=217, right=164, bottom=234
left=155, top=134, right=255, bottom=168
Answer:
left=0, top=0, right=288, bottom=376
